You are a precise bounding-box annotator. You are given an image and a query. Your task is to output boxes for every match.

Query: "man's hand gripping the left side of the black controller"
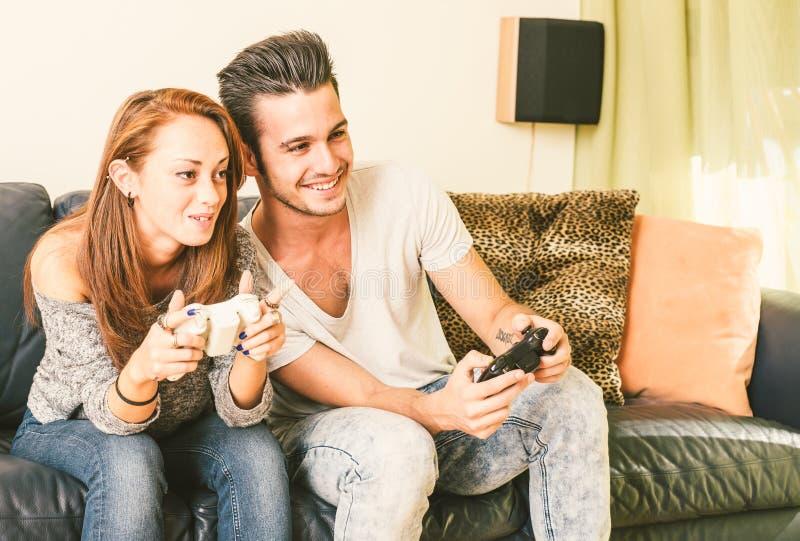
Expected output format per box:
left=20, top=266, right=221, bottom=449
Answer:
left=420, top=351, right=533, bottom=439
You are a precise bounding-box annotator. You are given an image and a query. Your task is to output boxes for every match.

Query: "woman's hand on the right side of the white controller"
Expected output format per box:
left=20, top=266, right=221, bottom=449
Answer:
left=236, top=271, right=294, bottom=361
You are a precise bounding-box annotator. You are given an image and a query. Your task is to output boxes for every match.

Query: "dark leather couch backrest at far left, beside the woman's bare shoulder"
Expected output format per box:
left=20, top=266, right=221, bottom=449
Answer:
left=0, top=182, right=53, bottom=428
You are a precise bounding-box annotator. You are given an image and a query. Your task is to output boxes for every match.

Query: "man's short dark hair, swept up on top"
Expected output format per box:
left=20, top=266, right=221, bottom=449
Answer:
left=217, top=30, right=339, bottom=163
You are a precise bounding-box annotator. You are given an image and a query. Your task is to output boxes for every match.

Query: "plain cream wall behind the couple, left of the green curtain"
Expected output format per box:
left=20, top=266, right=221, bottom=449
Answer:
left=0, top=0, right=579, bottom=197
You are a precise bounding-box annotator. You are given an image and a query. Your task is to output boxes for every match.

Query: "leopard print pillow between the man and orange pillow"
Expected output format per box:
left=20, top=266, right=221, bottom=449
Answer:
left=434, top=190, right=639, bottom=405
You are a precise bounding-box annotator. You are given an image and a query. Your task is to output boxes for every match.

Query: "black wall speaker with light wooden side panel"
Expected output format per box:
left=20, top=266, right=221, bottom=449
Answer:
left=497, top=17, right=605, bottom=124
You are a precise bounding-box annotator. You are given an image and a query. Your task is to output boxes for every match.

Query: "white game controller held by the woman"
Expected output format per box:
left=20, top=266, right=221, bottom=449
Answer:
left=167, top=293, right=261, bottom=381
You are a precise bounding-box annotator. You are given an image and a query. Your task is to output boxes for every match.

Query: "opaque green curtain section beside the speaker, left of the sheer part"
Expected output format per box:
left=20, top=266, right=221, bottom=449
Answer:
left=574, top=0, right=692, bottom=219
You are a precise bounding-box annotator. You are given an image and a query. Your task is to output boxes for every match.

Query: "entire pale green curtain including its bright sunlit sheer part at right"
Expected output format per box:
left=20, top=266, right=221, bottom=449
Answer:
left=574, top=0, right=800, bottom=290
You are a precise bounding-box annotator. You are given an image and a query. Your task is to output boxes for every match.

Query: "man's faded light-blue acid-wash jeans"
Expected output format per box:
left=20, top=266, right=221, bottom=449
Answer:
left=280, top=367, right=611, bottom=541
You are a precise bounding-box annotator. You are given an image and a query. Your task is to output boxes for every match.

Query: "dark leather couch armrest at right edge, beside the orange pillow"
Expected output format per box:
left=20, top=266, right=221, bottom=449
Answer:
left=747, top=289, right=800, bottom=428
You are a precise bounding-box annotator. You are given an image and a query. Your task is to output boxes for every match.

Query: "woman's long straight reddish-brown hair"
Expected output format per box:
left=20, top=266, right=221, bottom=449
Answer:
left=24, top=88, right=245, bottom=369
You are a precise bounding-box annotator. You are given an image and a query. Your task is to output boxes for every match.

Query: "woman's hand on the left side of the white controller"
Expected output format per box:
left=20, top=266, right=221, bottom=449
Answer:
left=125, top=290, right=206, bottom=385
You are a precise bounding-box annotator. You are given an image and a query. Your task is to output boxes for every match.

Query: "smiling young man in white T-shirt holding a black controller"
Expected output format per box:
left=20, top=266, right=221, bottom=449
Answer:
left=218, top=31, right=610, bottom=541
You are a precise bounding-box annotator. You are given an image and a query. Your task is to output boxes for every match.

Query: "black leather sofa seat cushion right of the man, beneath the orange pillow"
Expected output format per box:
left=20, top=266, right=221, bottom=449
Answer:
left=608, top=399, right=800, bottom=527
